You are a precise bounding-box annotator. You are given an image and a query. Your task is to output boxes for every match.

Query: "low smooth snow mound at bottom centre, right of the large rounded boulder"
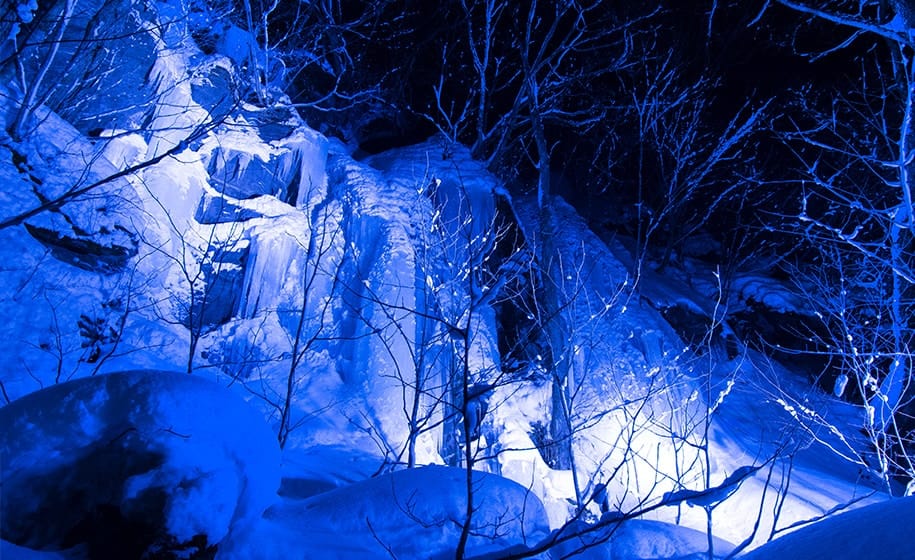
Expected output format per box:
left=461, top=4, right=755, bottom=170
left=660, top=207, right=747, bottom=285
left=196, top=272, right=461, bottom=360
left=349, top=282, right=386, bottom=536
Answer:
left=218, top=466, right=549, bottom=560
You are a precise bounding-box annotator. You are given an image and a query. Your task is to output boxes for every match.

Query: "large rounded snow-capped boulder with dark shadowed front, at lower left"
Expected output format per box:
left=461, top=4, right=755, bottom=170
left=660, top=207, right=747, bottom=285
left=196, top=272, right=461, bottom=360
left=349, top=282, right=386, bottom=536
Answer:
left=0, top=371, right=279, bottom=558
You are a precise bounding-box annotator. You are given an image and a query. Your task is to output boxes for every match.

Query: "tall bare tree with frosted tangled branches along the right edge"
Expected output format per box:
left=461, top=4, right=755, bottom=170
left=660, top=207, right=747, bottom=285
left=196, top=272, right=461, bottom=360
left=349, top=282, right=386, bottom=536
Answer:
left=764, top=0, right=915, bottom=490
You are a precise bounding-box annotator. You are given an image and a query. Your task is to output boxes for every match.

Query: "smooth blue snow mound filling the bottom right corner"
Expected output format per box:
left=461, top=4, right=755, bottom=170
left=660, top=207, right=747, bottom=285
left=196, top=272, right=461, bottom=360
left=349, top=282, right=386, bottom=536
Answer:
left=740, top=497, right=915, bottom=560
